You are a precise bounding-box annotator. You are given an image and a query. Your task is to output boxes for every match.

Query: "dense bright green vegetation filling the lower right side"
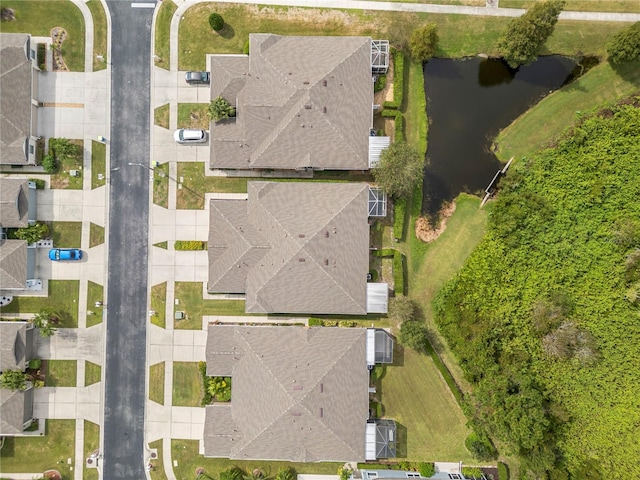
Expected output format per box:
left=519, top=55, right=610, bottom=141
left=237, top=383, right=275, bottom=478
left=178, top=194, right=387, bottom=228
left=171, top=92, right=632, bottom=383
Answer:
left=435, top=97, right=640, bottom=478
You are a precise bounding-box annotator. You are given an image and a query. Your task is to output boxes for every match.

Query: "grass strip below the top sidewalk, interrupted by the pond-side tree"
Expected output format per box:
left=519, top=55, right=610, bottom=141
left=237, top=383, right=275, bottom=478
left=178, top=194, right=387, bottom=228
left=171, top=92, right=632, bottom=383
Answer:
left=178, top=3, right=625, bottom=70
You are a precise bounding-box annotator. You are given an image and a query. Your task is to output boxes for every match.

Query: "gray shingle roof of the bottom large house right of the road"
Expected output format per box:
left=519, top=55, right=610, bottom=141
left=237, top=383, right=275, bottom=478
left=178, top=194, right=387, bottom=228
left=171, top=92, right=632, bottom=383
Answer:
left=204, top=325, right=369, bottom=462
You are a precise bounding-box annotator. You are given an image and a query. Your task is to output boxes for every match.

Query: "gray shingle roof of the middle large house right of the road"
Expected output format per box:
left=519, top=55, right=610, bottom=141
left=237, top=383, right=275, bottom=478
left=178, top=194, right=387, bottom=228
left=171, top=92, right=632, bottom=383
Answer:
left=207, top=182, right=369, bottom=315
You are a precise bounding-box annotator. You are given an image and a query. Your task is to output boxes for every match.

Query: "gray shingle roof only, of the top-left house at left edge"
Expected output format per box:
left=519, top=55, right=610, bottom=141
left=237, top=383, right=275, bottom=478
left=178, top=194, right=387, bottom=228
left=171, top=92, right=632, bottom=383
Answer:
left=0, top=33, right=32, bottom=164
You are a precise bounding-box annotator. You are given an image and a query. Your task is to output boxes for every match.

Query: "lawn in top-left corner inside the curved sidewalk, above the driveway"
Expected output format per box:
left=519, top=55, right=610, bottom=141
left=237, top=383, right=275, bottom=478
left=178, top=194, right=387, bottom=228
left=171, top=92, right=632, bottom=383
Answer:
left=0, top=0, right=84, bottom=72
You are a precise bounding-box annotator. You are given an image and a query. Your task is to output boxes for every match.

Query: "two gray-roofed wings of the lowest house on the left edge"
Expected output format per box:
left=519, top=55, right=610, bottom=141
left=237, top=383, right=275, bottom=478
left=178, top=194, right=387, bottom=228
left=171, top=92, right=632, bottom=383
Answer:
left=0, top=321, right=35, bottom=436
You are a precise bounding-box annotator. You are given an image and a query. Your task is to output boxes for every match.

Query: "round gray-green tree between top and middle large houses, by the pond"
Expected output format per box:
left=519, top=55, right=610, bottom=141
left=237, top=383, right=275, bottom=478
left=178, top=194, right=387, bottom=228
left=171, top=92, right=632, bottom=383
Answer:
left=373, top=142, right=424, bottom=198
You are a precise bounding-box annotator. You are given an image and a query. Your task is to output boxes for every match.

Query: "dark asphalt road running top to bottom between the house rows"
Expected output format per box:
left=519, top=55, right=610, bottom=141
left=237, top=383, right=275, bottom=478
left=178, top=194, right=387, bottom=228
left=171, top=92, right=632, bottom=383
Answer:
left=102, top=0, right=155, bottom=480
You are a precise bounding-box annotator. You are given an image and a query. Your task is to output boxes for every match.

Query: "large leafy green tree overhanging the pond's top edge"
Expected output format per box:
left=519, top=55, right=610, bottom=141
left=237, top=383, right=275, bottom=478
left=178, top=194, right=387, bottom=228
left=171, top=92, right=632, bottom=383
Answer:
left=498, top=0, right=565, bottom=68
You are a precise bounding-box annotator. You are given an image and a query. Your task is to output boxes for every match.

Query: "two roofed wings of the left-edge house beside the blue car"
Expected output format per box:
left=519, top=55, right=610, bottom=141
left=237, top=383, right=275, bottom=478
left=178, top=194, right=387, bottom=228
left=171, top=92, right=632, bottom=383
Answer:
left=0, top=177, right=36, bottom=295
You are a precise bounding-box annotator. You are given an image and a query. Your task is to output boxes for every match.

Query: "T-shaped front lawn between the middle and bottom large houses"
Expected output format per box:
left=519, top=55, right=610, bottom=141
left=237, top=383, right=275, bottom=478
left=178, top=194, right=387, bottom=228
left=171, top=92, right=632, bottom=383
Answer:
left=174, top=282, right=245, bottom=330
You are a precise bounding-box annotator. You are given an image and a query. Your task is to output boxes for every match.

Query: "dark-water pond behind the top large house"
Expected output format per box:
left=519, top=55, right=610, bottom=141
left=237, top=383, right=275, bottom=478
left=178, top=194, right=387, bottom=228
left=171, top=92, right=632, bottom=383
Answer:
left=422, top=56, right=575, bottom=214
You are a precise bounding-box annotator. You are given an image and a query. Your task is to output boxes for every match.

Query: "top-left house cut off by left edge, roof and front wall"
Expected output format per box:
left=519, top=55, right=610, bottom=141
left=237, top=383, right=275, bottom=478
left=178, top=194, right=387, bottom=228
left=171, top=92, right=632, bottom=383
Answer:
left=0, top=33, right=40, bottom=166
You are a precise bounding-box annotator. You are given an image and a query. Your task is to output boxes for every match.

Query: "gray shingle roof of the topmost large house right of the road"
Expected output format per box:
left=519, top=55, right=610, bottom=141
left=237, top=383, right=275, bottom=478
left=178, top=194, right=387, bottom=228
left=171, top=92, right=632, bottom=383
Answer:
left=210, top=34, right=373, bottom=170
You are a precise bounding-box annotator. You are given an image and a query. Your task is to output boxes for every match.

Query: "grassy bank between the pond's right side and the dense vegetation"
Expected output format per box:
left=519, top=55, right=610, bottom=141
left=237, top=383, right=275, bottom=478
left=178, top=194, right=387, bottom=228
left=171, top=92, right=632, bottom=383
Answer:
left=496, top=62, right=640, bottom=162
